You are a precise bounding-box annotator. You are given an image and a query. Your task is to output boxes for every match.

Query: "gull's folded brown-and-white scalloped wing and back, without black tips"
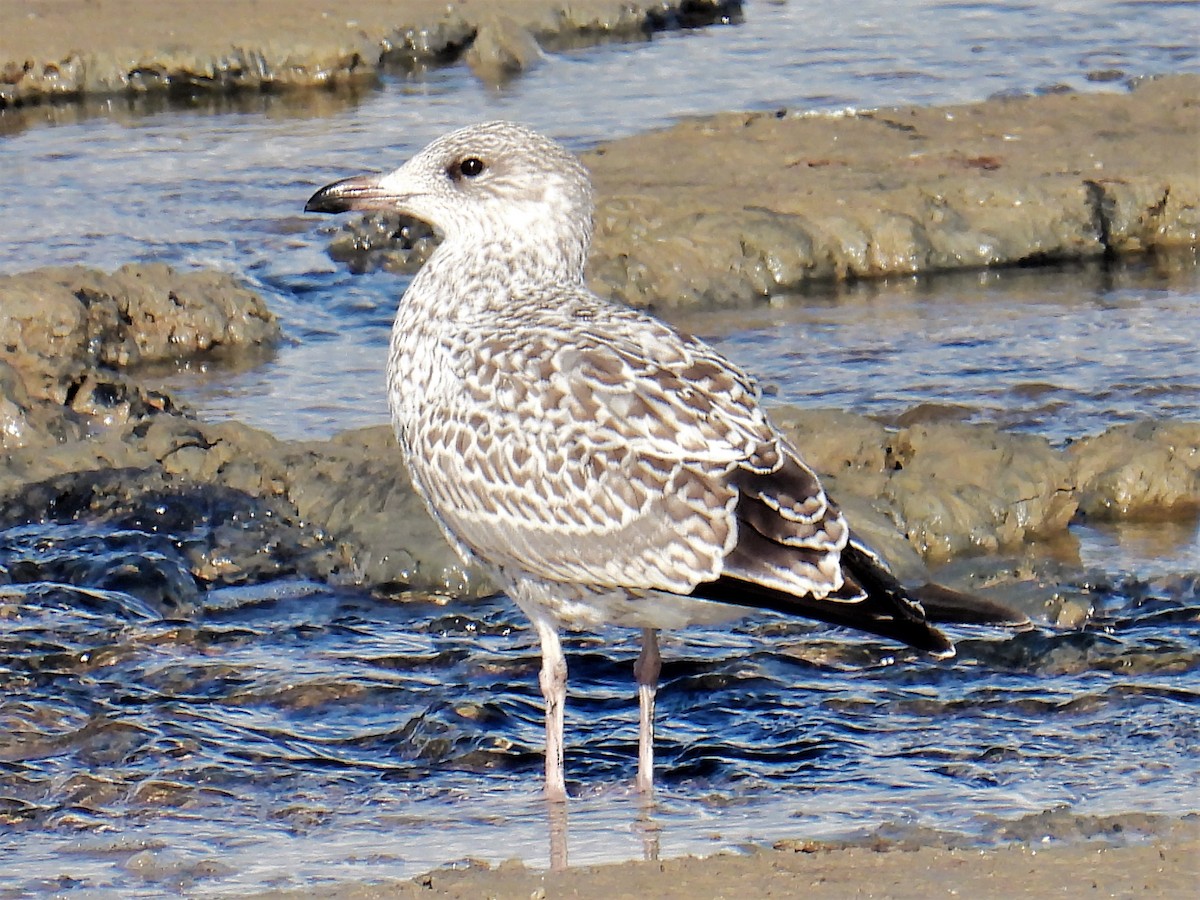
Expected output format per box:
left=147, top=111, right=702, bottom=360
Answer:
left=410, top=290, right=860, bottom=604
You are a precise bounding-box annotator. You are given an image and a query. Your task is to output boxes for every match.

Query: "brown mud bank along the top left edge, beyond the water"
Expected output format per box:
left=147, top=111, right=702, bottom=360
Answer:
left=0, top=0, right=742, bottom=109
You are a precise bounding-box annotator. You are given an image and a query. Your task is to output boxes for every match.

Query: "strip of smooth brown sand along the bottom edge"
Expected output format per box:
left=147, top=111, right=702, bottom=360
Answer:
left=255, top=820, right=1200, bottom=900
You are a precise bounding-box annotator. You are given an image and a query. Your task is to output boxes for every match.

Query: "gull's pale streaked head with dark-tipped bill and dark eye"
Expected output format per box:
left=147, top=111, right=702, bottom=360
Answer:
left=305, top=122, right=593, bottom=277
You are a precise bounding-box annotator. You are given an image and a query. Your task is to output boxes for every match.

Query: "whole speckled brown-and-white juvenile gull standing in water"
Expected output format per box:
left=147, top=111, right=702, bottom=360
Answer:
left=305, top=122, right=1020, bottom=799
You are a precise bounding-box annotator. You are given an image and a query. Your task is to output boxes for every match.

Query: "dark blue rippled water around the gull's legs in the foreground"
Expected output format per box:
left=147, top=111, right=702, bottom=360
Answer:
left=0, top=556, right=1200, bottom=894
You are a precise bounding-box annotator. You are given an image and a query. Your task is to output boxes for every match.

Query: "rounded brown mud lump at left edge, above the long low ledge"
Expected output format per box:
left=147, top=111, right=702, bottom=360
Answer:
left=0, top=264, right=280, bottom=450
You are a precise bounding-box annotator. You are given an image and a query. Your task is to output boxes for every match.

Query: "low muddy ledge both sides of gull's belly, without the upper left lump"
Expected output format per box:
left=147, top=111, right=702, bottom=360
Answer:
left=0, top=376, right=1200, bottom=602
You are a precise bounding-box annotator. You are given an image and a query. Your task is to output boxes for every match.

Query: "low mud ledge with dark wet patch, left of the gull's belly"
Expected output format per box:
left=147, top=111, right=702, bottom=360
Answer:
left=0, top=413, right=492, bottom=595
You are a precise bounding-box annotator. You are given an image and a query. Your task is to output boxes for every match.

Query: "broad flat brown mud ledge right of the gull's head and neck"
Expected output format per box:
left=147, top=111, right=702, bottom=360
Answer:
left=584, top=76, right=1200, bottom=307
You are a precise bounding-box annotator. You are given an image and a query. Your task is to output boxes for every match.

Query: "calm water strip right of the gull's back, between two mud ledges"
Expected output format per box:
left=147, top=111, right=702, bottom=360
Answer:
left=677, top=254, right=1200, bottom=443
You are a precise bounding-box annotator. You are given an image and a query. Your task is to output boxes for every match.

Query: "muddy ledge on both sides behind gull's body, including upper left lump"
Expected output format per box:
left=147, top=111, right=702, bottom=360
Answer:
left=0, top=265, right=1200, bottom=622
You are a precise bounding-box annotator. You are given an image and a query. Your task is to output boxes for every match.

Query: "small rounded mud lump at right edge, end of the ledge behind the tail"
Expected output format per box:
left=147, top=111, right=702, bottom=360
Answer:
left=1068, top=421, right=1200, bottom=520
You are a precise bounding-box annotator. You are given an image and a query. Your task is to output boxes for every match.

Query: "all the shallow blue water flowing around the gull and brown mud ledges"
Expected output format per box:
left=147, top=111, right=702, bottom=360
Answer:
left=0, top=2, right=1200, bottom=896
